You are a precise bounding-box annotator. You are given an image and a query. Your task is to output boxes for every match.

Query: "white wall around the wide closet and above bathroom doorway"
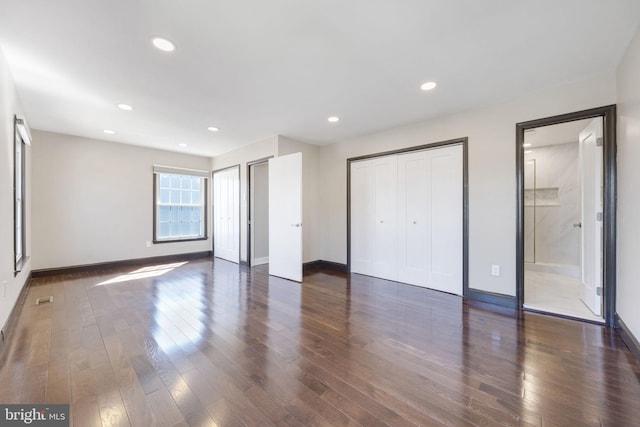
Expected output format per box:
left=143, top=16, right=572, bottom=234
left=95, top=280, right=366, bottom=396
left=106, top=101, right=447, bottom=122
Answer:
left=319, top=72, right=616, bottom=295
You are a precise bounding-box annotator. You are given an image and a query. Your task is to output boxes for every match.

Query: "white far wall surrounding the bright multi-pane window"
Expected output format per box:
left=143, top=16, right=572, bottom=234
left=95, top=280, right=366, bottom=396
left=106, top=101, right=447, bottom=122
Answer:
left=32, top=131, right=211, bottom=270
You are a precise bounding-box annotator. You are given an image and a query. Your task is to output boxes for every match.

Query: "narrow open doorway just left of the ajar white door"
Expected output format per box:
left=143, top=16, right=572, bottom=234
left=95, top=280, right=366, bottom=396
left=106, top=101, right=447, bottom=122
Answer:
left=247, top=159, right=269, bottom=267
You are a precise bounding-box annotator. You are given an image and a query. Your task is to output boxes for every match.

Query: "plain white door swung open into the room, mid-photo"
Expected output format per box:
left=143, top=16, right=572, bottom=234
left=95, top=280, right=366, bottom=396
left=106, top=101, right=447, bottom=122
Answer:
left=269, top=153, right=302, bottom=282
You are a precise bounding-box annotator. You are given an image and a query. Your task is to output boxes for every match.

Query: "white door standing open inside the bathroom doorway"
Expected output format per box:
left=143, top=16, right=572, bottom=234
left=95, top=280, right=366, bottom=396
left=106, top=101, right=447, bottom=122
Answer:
left=580, top=118, right=603, bottom=316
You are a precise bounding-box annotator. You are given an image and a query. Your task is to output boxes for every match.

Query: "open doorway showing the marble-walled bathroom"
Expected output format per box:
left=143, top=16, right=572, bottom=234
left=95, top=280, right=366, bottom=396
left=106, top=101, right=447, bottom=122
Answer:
left=524, top=117, right=603, bottom=322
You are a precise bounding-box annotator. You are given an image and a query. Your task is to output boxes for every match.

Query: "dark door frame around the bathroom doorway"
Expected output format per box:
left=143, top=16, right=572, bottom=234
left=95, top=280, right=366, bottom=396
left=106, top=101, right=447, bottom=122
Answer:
left=515, top=104, right=617, bottom=326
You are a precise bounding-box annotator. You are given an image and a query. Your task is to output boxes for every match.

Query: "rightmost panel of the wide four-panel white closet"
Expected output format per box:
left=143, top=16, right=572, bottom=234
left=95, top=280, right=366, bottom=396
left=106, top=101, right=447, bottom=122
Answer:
left=427, top=146, right=463, bottom=295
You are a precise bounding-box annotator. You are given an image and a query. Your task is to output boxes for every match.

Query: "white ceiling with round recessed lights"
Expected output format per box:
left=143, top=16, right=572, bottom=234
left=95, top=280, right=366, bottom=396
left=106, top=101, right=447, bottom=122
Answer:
left=0, top=0, right=640, bottom=156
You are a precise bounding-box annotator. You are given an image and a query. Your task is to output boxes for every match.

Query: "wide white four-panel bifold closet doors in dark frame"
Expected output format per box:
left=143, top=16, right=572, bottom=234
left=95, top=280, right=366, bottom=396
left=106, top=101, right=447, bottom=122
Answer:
left=350, top=144, right=464, bottom=295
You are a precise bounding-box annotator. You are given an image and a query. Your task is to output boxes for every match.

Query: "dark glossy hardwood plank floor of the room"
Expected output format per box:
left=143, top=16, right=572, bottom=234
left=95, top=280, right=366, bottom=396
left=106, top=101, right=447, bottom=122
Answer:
left=0, top=259, right=640, bottom=427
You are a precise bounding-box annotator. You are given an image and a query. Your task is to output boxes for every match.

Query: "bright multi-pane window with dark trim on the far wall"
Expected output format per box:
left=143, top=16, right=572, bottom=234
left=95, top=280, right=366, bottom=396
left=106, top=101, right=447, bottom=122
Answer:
left=153, top=166, right=208, bottom=243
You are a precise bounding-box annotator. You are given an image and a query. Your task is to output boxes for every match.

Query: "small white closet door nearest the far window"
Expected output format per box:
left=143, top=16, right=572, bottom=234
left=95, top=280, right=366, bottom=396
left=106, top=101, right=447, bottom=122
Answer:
left=213, top=167, right=240, bottom=263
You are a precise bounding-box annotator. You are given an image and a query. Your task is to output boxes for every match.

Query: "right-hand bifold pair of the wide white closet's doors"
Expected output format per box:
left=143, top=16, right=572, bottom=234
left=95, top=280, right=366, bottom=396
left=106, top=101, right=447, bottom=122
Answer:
left=398, top=145, right=463, bottom=295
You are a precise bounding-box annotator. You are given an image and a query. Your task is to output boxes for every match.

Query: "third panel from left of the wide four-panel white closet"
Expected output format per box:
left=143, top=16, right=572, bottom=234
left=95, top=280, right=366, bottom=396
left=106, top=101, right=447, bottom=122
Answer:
left=398, top=151, right=428, bottom=286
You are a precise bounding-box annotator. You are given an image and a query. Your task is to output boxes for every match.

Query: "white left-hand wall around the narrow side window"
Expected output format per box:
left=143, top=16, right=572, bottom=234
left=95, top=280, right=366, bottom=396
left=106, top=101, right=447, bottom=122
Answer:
left=0, top=46, right=33, bottom=330
